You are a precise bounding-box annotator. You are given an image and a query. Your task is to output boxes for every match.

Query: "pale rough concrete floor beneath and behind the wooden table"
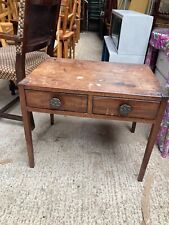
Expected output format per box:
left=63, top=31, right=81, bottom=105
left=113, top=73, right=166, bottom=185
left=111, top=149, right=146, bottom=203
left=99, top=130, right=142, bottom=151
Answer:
left=0, top=33, right=169, bottom=225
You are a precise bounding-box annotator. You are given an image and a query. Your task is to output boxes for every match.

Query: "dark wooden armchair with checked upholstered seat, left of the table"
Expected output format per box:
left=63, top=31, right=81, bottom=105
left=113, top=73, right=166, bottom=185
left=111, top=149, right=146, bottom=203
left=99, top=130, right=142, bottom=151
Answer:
left=0, top=0, right=60, bottom=121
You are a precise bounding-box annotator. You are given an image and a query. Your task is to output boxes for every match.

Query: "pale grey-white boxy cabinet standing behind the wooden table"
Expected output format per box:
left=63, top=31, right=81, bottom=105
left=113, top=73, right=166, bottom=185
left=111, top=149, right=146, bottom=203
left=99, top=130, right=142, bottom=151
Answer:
left=102, top=10, right=153, bottom=64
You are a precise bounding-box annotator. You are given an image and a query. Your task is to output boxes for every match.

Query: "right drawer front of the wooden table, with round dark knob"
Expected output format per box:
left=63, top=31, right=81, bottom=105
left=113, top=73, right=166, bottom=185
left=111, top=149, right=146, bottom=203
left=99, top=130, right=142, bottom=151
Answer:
left=93, top=96, right=159, bottom=119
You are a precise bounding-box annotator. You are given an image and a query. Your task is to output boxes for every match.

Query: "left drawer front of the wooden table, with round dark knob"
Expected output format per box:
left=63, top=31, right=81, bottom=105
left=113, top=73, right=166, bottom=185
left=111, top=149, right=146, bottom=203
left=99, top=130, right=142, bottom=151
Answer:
left=26, top=90, right=87, bottom=113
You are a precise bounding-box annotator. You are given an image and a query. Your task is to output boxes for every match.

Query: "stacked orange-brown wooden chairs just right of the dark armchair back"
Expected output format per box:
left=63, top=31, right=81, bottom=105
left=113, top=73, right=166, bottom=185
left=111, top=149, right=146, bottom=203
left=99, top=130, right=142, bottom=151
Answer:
left=55, top=0, right=81, bottom=58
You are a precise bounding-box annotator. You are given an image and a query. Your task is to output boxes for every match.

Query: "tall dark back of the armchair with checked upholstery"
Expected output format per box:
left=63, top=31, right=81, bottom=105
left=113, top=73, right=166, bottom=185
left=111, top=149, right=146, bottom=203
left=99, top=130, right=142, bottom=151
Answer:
left=17, top=0, right=60, bottom=56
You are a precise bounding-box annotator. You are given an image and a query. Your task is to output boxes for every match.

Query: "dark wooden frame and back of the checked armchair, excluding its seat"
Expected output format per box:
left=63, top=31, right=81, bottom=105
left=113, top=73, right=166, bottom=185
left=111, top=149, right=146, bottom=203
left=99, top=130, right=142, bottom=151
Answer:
left=0, top=0, right=60, bottom=120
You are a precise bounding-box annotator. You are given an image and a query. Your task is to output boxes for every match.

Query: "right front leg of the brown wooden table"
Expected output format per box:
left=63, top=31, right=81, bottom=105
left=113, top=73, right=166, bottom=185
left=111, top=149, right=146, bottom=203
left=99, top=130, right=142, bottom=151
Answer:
left=137, top=101, right=167, bottom=181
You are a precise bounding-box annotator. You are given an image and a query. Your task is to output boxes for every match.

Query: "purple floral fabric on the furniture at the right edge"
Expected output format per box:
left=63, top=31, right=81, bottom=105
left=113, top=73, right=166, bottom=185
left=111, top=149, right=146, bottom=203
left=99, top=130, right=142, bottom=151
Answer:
left=146, top=28, right=169, bottom=158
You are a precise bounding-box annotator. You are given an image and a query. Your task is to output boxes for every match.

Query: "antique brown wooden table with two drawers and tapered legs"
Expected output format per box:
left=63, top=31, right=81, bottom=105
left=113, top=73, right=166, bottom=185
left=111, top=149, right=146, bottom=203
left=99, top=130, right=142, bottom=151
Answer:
left=19, top=58, right=167, bottom=181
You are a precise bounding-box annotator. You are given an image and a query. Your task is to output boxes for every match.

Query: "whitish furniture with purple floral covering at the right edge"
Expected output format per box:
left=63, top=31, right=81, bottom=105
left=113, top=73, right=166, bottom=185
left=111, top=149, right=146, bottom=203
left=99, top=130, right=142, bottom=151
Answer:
left=146, top=28, right=169, bottom=157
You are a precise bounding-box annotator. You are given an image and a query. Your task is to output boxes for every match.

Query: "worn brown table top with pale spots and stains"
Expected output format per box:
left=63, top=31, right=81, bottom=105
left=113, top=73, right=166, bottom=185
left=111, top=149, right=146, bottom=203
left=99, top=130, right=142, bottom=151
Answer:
left=19, top=58, right=162, bottom=99
